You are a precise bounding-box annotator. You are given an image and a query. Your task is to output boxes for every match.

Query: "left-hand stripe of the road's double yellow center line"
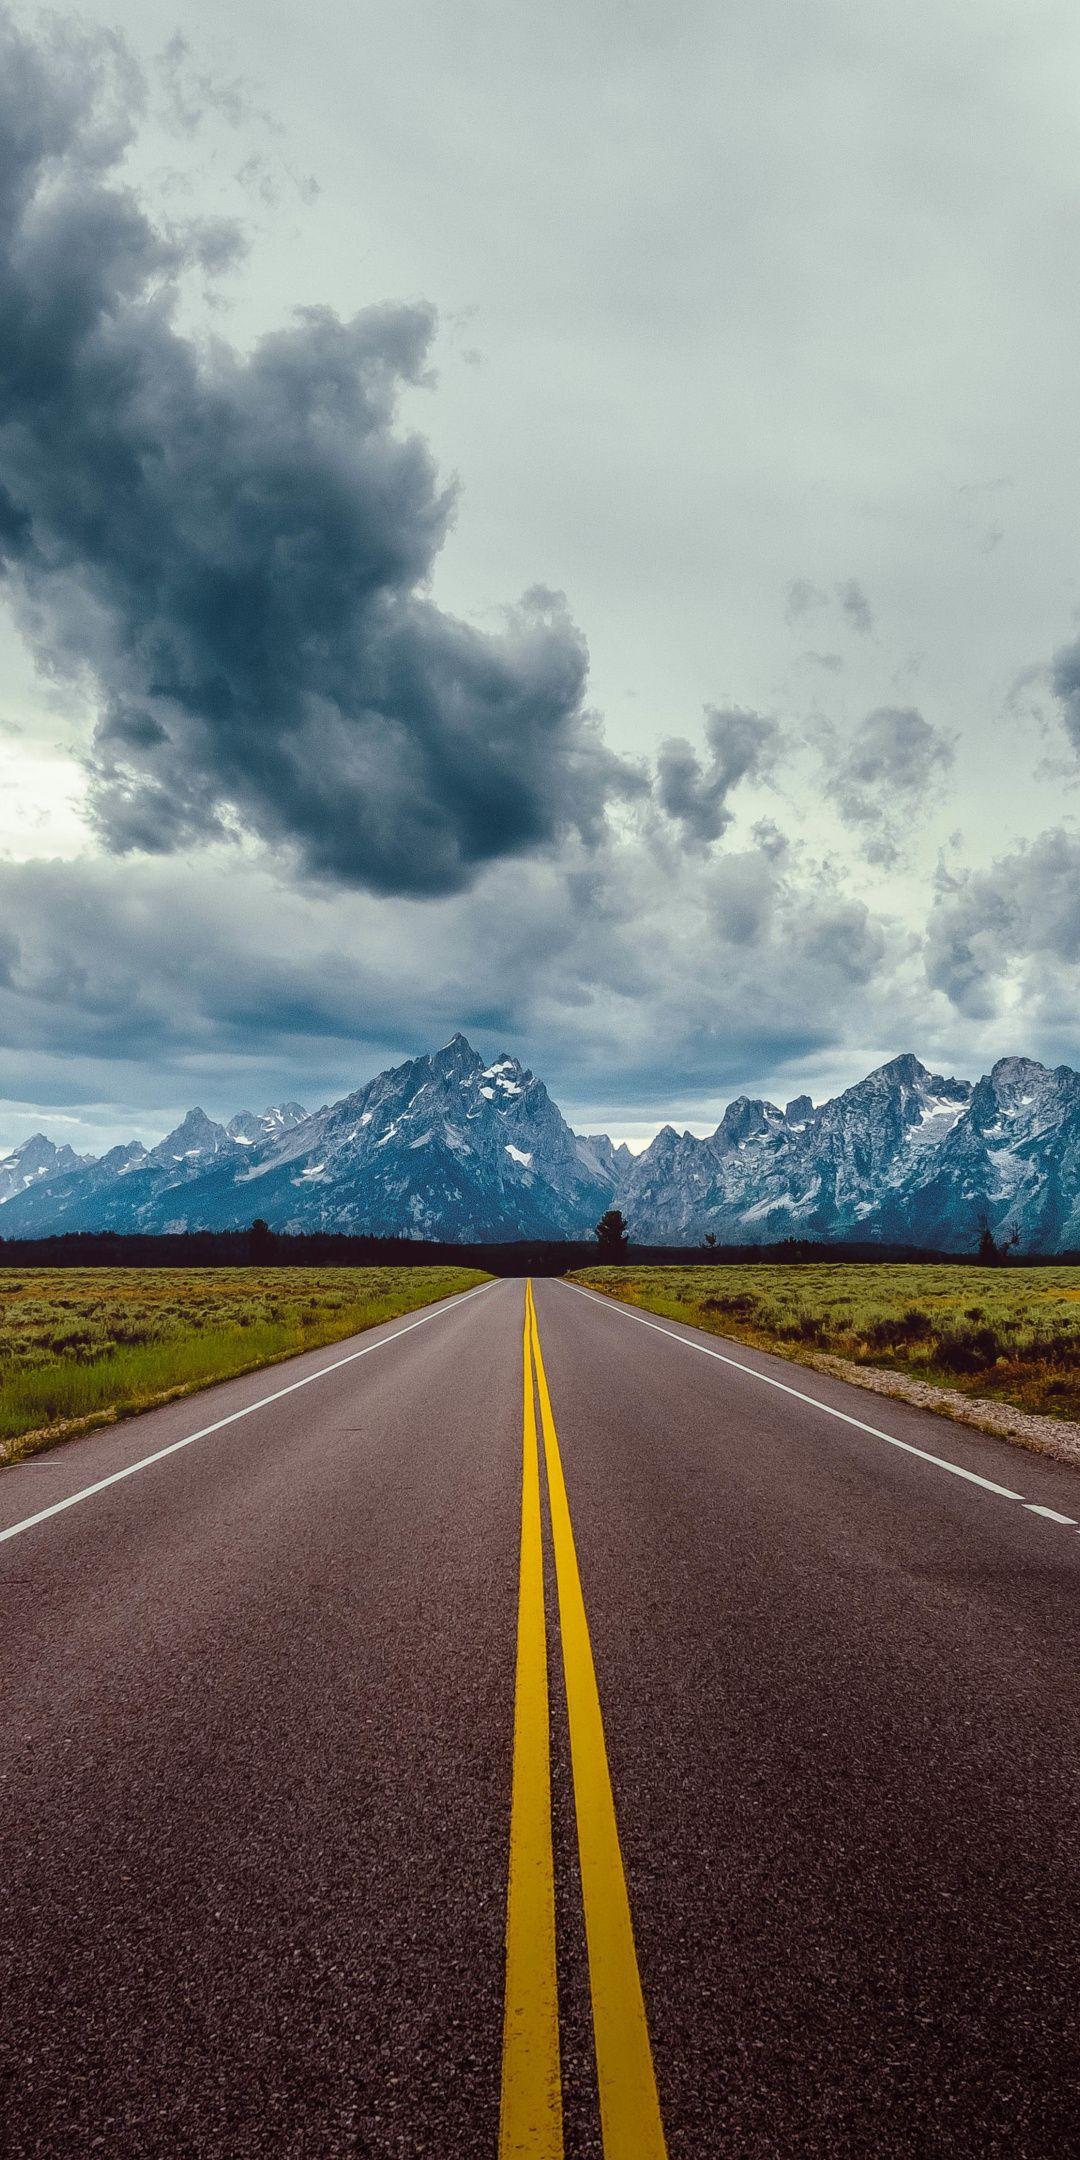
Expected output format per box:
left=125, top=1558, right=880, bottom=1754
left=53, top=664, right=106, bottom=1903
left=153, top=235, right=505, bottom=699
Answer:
left=499, top=1292, right=562, bottom=2160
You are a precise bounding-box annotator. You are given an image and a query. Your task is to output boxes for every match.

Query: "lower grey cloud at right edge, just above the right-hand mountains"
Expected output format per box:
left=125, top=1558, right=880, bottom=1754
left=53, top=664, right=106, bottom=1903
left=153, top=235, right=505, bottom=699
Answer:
left=927, top=827, right=1080, bottom=1032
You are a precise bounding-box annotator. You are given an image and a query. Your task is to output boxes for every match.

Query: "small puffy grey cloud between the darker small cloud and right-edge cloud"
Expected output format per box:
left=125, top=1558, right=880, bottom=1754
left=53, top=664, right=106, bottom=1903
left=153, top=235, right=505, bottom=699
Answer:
left=827, top=704, right=953, bottom=864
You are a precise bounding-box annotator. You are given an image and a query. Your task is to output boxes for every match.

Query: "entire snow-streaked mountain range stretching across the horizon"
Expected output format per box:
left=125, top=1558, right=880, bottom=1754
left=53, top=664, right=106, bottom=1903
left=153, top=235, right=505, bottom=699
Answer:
left=0, top=1035, right=1080, bottom=1253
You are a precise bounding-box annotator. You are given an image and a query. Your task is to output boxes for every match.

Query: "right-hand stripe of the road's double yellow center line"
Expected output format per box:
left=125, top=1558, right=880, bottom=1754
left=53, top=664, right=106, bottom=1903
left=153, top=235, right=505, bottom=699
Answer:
left=525, top=1283, right=667, bottom=2160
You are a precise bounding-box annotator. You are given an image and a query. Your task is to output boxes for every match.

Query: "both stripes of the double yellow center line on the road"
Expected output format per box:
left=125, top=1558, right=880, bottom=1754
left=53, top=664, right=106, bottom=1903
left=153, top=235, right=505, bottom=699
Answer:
left=499, top=1283, right=667, bottom=2160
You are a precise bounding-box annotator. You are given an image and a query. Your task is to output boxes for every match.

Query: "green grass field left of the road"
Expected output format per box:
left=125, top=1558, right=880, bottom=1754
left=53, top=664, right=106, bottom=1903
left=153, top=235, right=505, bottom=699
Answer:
left=0, top=1268, right=484, bottom=1462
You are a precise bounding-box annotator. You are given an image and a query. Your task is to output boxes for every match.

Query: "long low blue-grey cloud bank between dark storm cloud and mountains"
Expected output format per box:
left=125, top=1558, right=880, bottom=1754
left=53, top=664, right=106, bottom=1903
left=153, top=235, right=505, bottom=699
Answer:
left=0, top=834, right=901, bottom=1130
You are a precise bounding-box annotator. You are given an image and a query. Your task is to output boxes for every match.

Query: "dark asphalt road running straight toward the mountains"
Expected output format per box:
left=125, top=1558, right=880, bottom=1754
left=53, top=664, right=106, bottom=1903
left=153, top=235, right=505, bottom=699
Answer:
left=0, top=1281, right=1080, bottom=2160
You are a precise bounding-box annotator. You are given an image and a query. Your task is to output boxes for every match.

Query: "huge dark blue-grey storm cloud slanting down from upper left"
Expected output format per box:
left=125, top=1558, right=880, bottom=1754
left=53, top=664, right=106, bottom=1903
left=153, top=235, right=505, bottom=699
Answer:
left=0, top=15, right=644, bottom=894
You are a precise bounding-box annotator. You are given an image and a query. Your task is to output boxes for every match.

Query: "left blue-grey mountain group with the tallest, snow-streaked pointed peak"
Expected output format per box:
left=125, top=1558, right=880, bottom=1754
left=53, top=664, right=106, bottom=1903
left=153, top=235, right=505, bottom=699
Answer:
left=0, top=1035, right=618, bottom=1240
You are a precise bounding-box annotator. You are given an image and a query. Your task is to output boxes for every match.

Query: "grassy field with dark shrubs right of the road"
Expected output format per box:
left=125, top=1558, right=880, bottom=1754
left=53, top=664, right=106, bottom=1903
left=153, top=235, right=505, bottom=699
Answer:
left=577, top=1261, right=1080, bottom=1421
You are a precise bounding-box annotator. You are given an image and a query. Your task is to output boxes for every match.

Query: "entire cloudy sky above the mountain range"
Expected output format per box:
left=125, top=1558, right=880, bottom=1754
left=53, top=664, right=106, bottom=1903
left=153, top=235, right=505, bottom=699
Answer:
left=0, top=0, right=1080, bottom=1151
